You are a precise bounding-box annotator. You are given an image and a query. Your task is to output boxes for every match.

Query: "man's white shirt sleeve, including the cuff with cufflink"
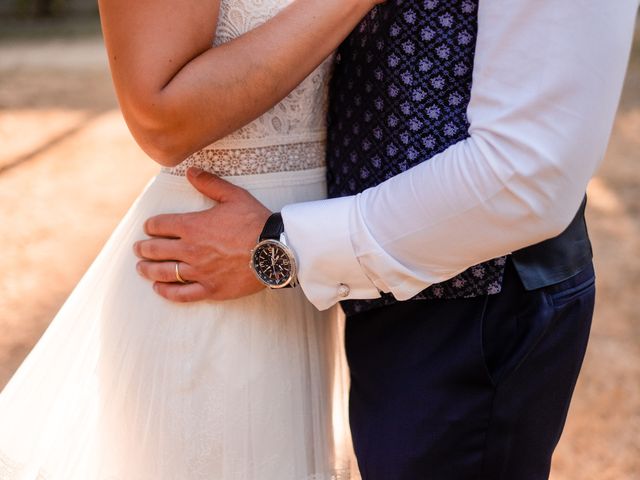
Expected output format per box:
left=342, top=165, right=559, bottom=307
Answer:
left=282, top=0, right=638, bottom=309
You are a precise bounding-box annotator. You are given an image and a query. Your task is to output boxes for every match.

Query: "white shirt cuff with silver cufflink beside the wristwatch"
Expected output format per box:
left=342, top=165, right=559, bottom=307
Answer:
left=282, top=197, right=380, bottom=310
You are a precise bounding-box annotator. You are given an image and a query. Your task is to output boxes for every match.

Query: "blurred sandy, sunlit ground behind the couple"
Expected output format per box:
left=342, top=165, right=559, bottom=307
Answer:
left=0, top=0, right=640, bottom=480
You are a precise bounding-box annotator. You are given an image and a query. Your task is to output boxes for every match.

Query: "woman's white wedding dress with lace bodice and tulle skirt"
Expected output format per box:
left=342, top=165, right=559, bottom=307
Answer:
left=0, top=0, right=350, bottom=480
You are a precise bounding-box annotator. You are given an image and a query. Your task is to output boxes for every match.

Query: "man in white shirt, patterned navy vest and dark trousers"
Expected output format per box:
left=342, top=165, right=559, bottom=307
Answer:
left=135, top=0, right=637, bottom=480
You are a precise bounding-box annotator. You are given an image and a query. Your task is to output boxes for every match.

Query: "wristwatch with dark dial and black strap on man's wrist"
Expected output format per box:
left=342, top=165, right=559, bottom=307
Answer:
left=249, top=212, right=298, bottom=289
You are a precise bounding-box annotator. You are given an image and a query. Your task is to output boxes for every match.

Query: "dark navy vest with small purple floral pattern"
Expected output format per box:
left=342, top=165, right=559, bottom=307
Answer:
left=327, top=0, right=505, bottom=314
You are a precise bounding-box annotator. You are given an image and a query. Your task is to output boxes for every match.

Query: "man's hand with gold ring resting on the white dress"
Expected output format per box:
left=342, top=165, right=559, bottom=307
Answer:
left=134, top=168, right=271, bottom=302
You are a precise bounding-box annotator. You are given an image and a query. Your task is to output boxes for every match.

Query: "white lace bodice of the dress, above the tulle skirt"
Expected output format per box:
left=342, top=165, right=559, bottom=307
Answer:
left=163, top=0, right=333, bottom=175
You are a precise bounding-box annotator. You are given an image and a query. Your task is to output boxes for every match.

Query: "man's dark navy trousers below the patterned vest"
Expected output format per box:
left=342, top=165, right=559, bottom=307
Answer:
left=345, top=261, right=595, bottom=480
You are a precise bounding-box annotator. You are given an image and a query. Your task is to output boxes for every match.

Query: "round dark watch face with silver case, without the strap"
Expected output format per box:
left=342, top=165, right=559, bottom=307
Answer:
left=252, top=240, right=295, bottom=288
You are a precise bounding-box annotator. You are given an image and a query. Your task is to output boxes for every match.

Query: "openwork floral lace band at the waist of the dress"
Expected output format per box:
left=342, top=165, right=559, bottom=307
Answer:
left=162, top=141, right=325, bottom=177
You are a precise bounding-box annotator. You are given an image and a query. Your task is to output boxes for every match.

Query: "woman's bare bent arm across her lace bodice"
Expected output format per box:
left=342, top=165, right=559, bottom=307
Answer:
left=99, top=0, right=380, bottom=166
